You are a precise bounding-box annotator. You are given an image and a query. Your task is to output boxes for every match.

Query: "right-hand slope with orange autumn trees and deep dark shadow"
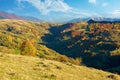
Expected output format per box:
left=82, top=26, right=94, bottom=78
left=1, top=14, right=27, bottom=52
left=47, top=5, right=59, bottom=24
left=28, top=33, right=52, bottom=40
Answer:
left=42, top=22, right=120, bottom=73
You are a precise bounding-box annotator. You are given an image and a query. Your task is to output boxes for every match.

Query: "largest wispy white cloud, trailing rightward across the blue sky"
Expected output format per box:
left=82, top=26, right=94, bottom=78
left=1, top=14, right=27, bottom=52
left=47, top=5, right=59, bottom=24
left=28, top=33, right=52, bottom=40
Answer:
left=17, top=0, right=94, bottom=17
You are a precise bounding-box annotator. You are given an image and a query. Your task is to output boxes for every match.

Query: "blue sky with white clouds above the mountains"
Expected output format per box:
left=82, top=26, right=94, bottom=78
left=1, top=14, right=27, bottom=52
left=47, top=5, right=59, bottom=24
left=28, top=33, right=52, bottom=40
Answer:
left=0, top=0, right=120, bottom=22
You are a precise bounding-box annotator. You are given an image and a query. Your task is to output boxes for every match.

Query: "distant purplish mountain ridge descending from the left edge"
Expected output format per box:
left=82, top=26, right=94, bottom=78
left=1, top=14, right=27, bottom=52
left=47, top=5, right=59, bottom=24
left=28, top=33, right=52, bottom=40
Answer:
left=0, top=12, right=43, bottom=22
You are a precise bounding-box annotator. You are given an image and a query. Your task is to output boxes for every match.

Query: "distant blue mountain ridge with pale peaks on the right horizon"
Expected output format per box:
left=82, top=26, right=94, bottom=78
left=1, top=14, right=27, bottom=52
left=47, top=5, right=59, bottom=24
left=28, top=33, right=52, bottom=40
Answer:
left=68, top=17, right=120, bottom=22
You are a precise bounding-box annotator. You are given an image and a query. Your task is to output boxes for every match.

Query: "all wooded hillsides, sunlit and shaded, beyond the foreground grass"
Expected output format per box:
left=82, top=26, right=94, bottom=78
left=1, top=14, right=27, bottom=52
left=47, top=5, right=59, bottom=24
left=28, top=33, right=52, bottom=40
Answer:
left=0, top=19, right=120, bottom=74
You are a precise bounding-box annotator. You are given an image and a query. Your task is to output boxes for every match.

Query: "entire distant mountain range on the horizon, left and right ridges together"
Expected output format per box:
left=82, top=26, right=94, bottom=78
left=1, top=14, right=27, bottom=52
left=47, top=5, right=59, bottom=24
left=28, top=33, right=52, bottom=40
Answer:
left=0, top=11, right=120, bottom=23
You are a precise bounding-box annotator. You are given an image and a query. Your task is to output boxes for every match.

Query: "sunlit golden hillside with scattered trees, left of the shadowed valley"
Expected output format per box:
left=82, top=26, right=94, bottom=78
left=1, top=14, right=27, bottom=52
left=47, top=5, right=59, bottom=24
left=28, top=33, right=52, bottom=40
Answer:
left=0, top=19, right=79, bottom=64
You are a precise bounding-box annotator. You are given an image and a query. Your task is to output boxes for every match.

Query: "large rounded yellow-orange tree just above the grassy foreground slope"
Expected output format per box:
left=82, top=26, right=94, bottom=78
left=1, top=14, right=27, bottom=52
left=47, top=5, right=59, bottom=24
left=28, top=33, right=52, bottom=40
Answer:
left=20, top=39, right=36, bottom=56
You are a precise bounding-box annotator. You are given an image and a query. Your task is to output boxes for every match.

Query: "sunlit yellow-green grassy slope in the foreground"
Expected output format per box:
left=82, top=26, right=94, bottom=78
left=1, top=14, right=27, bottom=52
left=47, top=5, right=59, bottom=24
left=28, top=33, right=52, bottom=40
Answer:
left=0, top=53, right=120, bottom=80
